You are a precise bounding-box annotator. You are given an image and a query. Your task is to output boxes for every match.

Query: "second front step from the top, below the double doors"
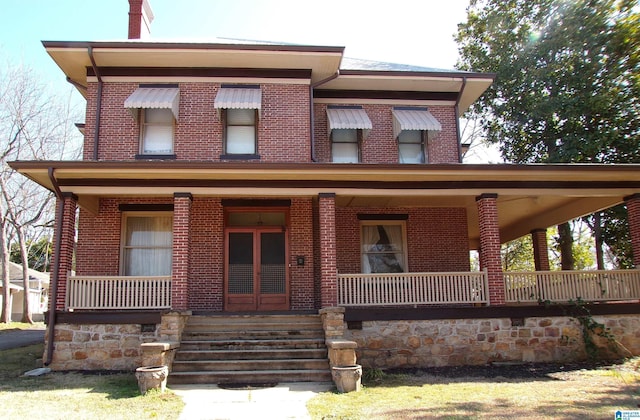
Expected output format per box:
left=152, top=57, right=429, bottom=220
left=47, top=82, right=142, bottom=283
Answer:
left=182, top=325, right=324, bottom=341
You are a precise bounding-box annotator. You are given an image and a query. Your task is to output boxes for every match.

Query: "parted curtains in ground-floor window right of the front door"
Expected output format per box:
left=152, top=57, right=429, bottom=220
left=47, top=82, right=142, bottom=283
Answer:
left=362, top=225, right=405, bottom=273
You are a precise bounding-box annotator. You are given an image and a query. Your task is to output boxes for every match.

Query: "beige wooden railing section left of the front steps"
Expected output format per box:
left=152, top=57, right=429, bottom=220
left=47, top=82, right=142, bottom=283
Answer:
left=67, top=276, right=171, bottom=310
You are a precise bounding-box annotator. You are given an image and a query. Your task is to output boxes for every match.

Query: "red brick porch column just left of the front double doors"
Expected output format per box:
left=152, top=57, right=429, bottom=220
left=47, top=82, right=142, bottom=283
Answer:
left=171, top=193, right=193, bottom=311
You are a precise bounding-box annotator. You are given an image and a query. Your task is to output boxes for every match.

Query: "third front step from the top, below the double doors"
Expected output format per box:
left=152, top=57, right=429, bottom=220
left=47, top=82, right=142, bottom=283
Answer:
left=178, top=338, right=325, bottom=352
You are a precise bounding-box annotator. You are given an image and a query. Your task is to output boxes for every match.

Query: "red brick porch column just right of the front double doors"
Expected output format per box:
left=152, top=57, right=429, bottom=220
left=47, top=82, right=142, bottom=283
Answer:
left=319, top=193, right=338, bottom=308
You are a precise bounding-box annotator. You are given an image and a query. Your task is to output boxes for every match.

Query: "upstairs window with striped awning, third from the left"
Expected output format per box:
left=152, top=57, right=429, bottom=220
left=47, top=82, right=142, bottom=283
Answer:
left=327, top=105, right=373, bottom=163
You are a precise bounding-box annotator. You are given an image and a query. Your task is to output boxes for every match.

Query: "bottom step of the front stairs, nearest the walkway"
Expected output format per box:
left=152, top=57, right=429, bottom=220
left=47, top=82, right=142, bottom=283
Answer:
left=167, top=368, right=331, bottom=385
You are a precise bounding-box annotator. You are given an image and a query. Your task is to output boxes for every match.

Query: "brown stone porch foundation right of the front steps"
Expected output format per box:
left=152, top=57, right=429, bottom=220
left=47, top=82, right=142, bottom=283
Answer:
left=344, top=315, right=640, bottom=368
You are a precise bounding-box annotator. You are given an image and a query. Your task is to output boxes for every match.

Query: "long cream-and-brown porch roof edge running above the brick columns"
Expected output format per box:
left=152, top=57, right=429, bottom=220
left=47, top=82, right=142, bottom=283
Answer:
left=9, top=160, right=640, bottom=189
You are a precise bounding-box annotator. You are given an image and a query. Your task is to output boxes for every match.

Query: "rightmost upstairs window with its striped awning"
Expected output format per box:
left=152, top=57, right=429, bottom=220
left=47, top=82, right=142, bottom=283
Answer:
left=393, top=107, right=442, bottom=163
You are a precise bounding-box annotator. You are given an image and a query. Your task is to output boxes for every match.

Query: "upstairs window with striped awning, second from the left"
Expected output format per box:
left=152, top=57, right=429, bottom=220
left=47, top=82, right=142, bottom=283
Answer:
left=214, top=85, right=262, bottom=159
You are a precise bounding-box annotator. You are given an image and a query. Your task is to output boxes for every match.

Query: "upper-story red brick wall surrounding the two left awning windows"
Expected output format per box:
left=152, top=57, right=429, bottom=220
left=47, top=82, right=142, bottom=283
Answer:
left=84, top=82, right=311, bottom=163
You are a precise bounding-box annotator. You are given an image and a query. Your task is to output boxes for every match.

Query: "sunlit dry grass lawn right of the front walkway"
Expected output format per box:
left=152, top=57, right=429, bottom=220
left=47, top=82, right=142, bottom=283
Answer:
left=307, top=358, right=640, bottom=419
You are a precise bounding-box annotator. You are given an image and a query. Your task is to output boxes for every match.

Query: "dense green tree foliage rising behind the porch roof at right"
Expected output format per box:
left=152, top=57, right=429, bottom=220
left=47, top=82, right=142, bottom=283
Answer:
left=456, top=0, right=640, bottom=261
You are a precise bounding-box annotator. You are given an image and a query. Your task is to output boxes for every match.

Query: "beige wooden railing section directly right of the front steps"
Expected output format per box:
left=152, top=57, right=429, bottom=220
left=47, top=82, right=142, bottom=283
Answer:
left=338, top=272, right=489, bottom=306
